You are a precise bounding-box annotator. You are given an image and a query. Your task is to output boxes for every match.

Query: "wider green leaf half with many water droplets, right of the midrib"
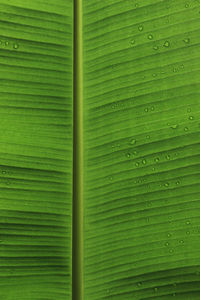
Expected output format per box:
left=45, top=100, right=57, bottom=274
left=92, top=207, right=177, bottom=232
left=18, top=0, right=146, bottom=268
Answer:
left=83, top=0, right=200, bottom=300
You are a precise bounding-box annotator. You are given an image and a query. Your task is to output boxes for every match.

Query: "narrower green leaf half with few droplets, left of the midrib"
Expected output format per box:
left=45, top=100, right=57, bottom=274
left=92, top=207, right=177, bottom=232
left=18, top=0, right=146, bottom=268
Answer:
left=0, top=0, right=73, bottom=300
